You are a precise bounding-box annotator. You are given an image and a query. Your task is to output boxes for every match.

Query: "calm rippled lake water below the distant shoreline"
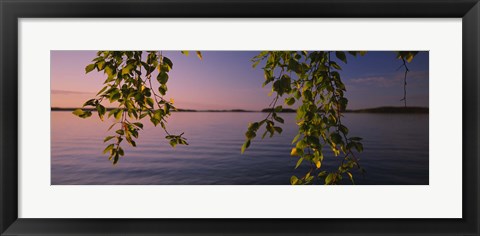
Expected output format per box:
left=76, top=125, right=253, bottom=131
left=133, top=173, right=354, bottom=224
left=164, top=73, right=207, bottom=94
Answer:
left=51, top=111, right=429, bottom=185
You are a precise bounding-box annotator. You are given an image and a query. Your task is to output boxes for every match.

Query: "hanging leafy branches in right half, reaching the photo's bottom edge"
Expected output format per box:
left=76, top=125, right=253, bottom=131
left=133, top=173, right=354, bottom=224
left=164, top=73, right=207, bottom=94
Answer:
left=241, top=51, right=417, bottom=185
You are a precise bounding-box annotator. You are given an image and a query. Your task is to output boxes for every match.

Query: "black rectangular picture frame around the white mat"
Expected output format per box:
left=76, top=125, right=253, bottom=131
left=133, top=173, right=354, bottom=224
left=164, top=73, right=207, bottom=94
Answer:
left=0, top=0, right=480, bottom=235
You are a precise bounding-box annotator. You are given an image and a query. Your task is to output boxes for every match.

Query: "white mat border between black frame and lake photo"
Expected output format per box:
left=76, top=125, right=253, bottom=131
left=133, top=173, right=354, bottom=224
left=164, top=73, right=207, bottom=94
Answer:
left=18, top=19, right=462, bottom=218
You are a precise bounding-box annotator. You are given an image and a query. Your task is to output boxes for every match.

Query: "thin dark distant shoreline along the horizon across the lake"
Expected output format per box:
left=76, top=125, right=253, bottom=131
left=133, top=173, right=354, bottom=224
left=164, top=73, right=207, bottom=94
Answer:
left=50, top=107, right=429, bottom=114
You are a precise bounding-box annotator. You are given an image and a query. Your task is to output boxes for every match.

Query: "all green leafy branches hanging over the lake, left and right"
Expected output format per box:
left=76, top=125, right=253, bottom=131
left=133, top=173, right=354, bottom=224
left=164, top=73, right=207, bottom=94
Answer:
left=73, top=51, right=418, bottom=185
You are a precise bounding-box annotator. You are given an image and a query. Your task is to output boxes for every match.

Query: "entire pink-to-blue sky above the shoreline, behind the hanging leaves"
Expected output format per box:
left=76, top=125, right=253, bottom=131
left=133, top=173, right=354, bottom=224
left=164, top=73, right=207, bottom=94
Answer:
left=50, top=51, right=429, bottom=110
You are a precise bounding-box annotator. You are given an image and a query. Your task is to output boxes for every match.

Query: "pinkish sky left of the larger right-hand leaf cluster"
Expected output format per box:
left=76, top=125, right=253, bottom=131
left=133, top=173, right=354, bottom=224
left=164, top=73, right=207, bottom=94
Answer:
left=51, top=51, right=272, bottom=110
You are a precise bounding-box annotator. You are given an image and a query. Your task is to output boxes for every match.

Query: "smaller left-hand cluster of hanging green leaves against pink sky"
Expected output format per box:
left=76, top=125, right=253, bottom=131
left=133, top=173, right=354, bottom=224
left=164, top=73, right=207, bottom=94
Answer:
left=73, top=51, right=202, bottom=164
